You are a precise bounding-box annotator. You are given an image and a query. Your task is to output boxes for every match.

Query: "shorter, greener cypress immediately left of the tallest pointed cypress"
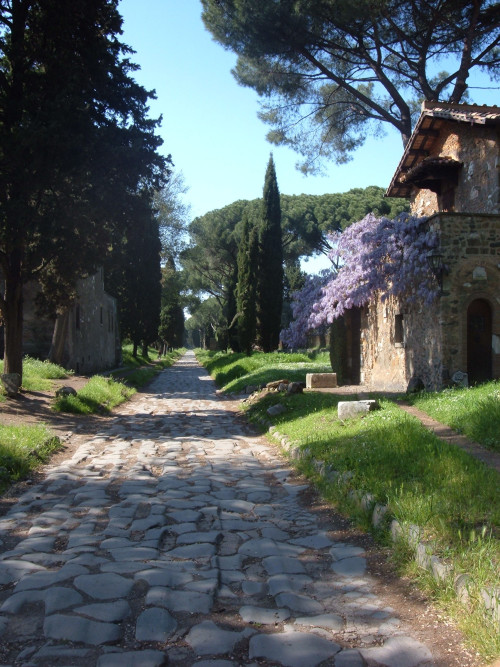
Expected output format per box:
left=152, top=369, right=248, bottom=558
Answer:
left=236, top=216, right=259, bottom=356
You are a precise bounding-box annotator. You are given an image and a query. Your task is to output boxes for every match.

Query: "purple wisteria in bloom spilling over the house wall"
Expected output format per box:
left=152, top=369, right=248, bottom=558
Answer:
left=283, top=213, right=438, bottom=346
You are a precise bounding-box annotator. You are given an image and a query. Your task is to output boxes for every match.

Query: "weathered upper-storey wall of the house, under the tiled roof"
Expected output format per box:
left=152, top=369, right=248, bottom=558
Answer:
left=411, top=122, right=500, bottom=216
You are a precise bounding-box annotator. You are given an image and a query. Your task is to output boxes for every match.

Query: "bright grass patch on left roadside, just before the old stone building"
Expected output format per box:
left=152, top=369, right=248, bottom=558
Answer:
left=53, top=375, right=135, bottom=415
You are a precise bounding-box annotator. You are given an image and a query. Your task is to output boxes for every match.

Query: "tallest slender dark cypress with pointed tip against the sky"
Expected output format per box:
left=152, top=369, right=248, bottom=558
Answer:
left=257, top=154, right=283, bottom=352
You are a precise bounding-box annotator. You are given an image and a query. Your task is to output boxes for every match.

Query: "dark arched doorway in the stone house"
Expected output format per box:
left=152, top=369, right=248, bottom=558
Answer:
left=467, top=299, right=492, bottom=384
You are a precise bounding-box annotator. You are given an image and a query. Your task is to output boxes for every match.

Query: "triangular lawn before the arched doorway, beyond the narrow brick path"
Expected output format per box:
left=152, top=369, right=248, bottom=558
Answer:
left=409, top=380, right=500, bottom=452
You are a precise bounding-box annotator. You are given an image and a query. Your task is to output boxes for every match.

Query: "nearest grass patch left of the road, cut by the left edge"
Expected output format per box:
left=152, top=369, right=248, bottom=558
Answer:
left=0, top=425, right=60, bottom=493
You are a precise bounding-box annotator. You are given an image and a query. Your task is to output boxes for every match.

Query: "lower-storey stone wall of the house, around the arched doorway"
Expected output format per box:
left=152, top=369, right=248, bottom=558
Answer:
left=361, top=213, right=500, bottom=391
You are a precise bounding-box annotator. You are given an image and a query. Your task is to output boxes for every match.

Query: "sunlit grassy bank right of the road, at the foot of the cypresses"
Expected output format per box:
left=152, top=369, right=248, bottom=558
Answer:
left=195, top=349, right=332, bottom=393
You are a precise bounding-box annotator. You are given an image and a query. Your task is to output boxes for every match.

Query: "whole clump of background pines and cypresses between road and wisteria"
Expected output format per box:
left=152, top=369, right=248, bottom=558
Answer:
left=180, top=167, right=408, bottom=354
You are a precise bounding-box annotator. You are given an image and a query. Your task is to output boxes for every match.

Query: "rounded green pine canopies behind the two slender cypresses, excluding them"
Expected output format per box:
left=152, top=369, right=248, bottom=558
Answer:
left=180, top=186, right=408, bottom=349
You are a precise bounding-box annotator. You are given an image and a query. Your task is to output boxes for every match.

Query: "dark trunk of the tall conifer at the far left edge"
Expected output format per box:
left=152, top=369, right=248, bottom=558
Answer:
left=3, top=267, right=23, bottom=379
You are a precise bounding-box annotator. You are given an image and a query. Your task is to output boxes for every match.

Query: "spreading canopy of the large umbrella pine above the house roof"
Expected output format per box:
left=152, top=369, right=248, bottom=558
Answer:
left=202, top=0, right=500, bottom=171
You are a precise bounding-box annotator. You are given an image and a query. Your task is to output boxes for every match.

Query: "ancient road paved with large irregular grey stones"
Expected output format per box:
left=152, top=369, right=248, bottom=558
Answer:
left=0, top=353, right=468, bottom=667
